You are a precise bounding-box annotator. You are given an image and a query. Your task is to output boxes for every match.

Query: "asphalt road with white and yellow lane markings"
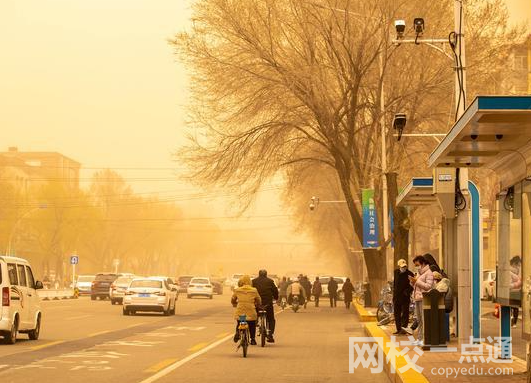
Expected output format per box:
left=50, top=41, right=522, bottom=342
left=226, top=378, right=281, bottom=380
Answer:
left=0, top=293, right=388, bottom=383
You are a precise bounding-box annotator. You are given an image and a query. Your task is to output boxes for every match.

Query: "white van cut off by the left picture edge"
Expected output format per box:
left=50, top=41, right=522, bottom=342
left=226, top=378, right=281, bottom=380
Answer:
left=0, top=256, right=42, bottom=344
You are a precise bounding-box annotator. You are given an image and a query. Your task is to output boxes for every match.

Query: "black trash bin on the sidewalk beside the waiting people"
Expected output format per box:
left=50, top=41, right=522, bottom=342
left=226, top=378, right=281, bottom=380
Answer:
left=422, top=289, right=447, bottom=349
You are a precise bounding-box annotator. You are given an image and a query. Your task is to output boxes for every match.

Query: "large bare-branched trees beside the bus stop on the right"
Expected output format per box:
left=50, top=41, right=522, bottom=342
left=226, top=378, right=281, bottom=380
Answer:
left=173, top=0, right=522, bottom=300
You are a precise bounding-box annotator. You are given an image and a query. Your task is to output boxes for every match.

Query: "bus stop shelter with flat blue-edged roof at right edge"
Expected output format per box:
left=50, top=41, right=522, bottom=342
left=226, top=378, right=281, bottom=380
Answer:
left=429, top=96, right=531, bottom=357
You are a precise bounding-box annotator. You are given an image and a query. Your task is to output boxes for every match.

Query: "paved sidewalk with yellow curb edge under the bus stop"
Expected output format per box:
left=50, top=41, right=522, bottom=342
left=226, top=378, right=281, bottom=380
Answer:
left=364, top=309, right=527, bottom=383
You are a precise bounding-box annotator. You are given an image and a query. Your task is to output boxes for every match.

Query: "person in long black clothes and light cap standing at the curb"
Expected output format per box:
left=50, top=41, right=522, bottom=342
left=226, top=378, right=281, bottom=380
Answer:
left=393, top=259, right=414, bottom=335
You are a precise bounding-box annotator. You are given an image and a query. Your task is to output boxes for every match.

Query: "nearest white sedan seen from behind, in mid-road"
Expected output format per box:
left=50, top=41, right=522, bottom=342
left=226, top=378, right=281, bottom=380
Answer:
left=123, top=277, right=178, bottom=315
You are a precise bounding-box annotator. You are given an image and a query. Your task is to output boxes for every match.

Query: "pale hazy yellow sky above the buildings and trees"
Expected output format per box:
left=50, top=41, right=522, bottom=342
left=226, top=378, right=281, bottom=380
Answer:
left=0, top=0, right=531, bottom=248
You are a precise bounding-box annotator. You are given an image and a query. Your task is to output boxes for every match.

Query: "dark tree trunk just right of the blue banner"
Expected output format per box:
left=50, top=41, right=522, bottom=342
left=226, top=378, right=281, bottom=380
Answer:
left=386, top=173, right=410, bottom=265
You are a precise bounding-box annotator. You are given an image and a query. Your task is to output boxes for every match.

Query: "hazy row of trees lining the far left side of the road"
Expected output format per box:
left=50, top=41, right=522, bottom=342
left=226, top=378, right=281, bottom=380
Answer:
left=0, top=170, right=218, bottom=280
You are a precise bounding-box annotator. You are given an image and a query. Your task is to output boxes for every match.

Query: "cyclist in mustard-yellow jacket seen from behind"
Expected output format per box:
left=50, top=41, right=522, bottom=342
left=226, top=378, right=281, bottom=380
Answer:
left=231, top=275, right=262, bottom=345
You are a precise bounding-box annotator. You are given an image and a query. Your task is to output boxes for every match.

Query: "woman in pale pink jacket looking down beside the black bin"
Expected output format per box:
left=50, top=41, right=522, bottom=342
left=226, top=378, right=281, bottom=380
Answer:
left=409, top=255, right=433, bottom=346
